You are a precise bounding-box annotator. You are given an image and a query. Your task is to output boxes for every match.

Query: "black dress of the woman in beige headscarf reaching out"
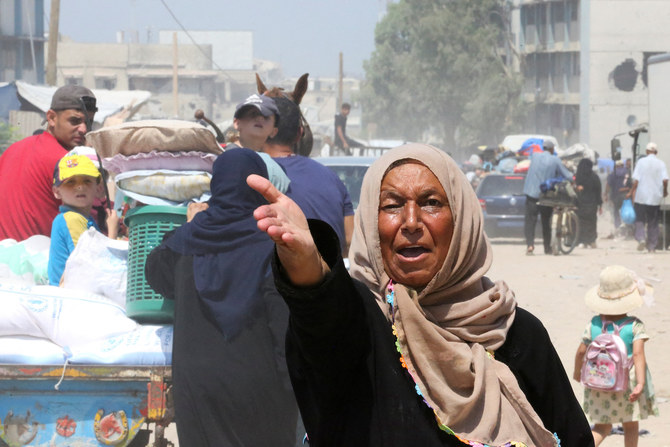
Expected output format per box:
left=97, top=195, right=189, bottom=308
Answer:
left=274, top=221, right=593, bottom=447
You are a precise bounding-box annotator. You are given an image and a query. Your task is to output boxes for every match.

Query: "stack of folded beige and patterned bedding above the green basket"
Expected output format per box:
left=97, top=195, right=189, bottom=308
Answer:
left=86, top=120, right=222, bottom=206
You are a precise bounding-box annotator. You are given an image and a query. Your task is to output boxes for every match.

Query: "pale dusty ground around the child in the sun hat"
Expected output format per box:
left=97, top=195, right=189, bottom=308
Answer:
left=160, top=216, right=670, bottom=447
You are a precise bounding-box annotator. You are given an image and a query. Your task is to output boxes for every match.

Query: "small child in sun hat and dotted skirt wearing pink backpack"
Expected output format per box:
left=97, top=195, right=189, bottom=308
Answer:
left=573, top=265, right=658, bottom=447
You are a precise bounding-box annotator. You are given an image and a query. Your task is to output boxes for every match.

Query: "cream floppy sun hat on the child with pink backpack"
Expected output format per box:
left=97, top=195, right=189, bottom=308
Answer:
left=584, top=265, right=652, bottom=315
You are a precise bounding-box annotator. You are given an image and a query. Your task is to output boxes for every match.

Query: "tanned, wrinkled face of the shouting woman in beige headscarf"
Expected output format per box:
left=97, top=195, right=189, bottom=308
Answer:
left=378, top=162, right=454, bottom=288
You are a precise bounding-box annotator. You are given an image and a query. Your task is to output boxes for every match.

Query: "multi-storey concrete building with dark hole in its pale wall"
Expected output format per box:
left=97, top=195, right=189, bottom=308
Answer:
left=508, top=0, right=670, bottom=157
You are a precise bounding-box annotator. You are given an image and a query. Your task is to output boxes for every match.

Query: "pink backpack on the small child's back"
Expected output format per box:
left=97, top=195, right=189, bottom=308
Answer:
left=581, top=319, right=633, bottom=392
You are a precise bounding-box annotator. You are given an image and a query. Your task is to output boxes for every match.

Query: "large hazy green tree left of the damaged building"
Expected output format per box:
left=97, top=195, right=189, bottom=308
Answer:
left=361, top=0, right=523, bottom=151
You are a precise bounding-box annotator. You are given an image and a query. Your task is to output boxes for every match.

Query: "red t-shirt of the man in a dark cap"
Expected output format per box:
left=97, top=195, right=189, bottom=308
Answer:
left=0, top=132, right=67, bottom=241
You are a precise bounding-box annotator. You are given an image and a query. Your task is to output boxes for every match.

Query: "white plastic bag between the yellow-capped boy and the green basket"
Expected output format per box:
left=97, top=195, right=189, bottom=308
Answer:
left=61, top=228, right=128, bottom=309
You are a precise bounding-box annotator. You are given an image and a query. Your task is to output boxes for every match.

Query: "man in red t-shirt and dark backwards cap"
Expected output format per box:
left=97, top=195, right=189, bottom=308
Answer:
left=0, top=85, right=98, bottom=241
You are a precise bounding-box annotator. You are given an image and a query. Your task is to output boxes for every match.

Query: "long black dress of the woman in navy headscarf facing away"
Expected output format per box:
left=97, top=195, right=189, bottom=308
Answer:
left=146, top=245, right=298, bottom=447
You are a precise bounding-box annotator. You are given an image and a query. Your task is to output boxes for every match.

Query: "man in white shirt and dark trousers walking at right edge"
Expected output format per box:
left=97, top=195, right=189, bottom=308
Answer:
left=629, top=142, right=668, bottom=253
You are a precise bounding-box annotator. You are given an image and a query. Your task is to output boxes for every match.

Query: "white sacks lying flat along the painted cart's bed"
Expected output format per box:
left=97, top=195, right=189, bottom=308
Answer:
left=0, top=283, right=172, bottom=365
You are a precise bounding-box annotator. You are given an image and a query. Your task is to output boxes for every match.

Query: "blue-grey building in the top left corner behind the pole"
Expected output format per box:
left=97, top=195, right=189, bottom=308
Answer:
left=0, top=0, right=45, bottom=84
